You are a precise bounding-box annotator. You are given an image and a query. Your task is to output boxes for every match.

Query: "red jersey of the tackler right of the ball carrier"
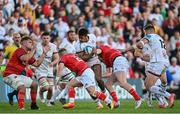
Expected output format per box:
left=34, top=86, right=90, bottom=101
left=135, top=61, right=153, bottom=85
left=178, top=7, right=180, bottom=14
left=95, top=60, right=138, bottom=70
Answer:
left=99, top=45, right=122, bottom=67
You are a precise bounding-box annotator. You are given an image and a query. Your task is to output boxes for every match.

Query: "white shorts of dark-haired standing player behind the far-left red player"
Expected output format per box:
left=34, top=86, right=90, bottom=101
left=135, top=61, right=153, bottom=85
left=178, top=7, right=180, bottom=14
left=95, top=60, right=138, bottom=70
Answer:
left=35, top=68, right=54, bottom=80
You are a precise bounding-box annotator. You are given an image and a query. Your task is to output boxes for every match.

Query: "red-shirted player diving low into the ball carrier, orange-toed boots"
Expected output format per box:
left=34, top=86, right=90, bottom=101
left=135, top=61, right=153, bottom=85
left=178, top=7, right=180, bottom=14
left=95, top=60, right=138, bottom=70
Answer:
left=59, top=49, right=114, bottom=109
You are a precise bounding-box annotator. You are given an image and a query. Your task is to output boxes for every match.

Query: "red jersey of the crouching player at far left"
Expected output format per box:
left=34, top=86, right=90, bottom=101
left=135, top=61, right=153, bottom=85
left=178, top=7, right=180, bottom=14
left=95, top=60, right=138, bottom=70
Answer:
left=3, top=48, right=35, bottom=77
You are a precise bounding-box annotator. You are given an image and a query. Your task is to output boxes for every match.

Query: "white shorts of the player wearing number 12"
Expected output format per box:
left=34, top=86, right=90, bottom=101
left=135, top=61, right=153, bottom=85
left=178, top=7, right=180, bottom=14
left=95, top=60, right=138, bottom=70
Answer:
left=145, top=62, right=169, bottom=76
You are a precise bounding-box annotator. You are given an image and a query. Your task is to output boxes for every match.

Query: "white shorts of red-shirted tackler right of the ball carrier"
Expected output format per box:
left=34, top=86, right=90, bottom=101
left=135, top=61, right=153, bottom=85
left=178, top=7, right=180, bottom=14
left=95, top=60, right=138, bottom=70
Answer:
left=113, top=56, right=129, bottom=72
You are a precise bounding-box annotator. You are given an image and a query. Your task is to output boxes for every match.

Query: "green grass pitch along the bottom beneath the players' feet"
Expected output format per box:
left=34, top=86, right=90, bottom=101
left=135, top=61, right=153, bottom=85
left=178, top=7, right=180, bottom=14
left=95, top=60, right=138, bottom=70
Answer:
left=0, top=100, right=180, bottom=114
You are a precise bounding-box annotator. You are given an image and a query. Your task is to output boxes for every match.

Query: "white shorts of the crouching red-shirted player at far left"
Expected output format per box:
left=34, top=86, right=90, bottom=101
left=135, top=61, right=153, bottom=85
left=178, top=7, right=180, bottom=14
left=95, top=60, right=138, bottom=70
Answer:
left=3, top=74, right=33, bottom=90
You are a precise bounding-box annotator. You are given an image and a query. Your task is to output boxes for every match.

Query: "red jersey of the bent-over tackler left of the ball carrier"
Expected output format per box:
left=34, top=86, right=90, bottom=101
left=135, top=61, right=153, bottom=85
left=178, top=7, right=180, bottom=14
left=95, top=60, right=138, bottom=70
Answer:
left=61, top=54, right=88, bottom=76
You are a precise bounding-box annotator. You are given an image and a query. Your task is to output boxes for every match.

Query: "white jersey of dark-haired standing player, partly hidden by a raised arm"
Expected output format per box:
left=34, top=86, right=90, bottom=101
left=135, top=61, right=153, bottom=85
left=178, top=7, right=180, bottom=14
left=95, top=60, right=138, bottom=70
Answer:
left=35, top=43, right=57, bottom=71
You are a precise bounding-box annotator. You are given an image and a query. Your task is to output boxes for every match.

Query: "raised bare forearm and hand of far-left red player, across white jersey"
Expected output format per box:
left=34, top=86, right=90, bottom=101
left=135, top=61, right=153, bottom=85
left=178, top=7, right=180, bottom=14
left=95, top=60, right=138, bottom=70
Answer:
left=32, top=47, right=50, bottom=67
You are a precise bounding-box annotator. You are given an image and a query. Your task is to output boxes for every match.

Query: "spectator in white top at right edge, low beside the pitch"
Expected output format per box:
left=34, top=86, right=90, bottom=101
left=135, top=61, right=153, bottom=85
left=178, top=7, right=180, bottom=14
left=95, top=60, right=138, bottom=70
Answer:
left=169, top=57, right=180, bottom=85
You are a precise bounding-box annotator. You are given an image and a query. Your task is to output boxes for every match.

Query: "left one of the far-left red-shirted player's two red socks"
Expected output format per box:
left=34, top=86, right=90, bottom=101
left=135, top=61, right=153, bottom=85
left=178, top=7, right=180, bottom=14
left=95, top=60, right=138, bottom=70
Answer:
left=18, top=90, right=25, bottom=108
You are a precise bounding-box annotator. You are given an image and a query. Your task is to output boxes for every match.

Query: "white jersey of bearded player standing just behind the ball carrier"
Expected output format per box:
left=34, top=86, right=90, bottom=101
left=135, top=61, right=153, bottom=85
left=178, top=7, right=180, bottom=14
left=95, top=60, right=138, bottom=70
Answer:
left=60, top=39, right=76, bottom=53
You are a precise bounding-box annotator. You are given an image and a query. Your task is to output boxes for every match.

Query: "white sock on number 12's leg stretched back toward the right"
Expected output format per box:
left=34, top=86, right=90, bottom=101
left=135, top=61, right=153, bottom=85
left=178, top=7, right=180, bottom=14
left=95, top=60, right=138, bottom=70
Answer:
left=150, top=86, right=171, bottom=98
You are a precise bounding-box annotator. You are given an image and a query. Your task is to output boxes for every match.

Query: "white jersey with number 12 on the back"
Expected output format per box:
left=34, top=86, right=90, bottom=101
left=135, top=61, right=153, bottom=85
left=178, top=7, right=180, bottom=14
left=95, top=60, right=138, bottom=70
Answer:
left=144, top=34, right=169, bottom=63
